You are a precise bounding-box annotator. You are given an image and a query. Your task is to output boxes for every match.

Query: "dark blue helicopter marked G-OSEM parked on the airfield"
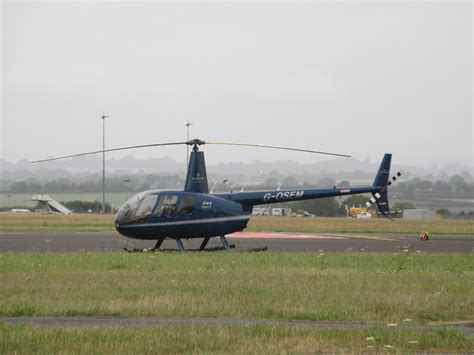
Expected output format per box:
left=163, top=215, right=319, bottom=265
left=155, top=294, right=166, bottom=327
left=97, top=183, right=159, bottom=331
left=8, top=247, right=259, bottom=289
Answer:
left=32, top=139, right=401, bottom=251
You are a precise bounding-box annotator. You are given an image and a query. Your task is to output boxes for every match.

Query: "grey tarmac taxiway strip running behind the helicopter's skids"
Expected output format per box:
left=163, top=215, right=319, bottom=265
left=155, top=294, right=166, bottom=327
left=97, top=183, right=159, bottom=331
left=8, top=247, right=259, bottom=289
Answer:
left=0, top=232, right=474, bottom=253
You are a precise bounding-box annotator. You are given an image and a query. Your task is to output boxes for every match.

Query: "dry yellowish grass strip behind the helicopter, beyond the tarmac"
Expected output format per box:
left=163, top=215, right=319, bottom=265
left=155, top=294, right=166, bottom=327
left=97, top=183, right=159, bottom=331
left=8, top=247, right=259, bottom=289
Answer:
left=0, top=212, right=474, bottom=235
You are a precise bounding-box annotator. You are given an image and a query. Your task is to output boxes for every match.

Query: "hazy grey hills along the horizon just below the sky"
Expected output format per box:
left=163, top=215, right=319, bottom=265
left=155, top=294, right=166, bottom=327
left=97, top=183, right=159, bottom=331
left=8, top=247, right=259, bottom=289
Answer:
left=0, top=156, right=473, bottom=182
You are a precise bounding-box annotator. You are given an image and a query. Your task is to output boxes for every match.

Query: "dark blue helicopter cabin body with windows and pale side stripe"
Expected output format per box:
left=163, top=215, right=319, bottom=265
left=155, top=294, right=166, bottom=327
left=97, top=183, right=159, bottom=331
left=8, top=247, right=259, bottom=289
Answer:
left=115, top=190, right=251, bottom=239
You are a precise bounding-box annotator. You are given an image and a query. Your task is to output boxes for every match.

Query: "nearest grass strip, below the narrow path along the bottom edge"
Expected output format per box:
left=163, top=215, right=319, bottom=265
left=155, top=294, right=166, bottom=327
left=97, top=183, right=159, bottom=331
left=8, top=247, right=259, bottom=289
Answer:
left=0, top=323, right=474, bottom=354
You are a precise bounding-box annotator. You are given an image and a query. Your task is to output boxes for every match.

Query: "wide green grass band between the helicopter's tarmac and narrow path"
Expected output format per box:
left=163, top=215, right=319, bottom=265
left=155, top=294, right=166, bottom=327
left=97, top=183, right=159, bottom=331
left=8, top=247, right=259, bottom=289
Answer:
left=0, top=252, right=474, bottom=323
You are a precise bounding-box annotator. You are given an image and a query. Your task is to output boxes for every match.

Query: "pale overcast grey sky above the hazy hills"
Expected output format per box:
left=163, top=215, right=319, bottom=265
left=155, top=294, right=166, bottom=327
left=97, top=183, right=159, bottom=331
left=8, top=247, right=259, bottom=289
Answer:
left=0, top=1, right=473, bottom=166
